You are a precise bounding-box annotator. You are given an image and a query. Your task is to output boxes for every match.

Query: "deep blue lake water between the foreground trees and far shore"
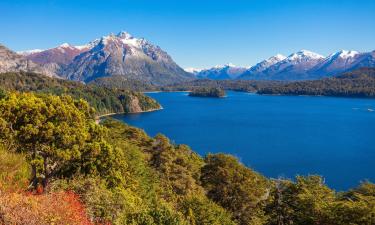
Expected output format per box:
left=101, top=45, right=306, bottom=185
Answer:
left=114, top=92, right=375, bottom=190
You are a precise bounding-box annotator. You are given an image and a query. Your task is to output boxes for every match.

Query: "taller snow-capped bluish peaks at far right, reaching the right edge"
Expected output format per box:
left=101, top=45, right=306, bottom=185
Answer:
left=239, top=50, right=375, bottom=80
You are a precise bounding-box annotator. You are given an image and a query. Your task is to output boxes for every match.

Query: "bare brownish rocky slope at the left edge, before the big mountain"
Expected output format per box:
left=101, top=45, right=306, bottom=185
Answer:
left=0, top=44, right=56, bottom=77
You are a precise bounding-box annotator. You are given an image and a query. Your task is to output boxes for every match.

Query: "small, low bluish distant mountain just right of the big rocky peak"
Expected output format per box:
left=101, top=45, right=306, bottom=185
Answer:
left=191, top=63, right=247, bottom=80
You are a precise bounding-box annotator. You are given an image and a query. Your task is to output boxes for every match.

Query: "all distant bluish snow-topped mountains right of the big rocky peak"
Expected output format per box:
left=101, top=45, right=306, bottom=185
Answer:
left=191, top=50, right=375, bottom=80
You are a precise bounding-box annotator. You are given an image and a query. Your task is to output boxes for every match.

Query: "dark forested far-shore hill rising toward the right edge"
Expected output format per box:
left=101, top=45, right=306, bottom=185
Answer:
left=258, top=68, right=375, bottom=98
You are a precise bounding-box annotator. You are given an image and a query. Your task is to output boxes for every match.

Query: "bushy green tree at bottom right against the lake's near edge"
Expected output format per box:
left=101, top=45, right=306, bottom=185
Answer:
left=267, top=176, right=335, bottom=225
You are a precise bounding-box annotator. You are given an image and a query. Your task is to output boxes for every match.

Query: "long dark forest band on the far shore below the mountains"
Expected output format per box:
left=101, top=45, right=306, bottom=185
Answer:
left=59, top=68, right=375, bottom=100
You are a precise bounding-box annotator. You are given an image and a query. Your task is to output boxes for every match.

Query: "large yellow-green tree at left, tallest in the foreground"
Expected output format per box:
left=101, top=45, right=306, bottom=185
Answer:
left=0, top=93, right=123, bottom=188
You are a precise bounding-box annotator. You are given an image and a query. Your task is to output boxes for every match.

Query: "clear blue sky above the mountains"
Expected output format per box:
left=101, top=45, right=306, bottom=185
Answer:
left=0, top=0, right=375, bottom=68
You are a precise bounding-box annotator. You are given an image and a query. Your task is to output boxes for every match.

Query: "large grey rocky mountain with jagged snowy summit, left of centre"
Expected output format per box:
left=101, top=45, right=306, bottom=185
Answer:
left=22, top=32, right=194, bottom=85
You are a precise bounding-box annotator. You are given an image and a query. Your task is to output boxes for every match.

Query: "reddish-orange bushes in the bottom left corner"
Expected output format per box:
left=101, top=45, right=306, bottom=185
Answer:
left=0, top=191, right=92, bottom=225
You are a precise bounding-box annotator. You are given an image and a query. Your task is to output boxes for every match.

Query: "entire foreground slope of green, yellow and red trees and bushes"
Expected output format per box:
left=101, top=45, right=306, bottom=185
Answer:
left=0, top=93, right=375, bottom=225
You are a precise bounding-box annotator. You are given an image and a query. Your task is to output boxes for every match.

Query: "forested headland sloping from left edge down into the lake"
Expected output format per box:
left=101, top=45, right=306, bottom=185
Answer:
left=0, top=72, right=160, bottom=114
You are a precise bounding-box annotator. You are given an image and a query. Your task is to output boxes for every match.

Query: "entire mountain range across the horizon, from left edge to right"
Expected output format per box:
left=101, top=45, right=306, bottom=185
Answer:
left=0, top=32, right=375, bottom=85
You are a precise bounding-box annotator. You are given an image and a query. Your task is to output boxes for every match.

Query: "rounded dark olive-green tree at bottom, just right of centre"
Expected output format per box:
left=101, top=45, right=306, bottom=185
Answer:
left=201, top=154, right=269, bottom=224
